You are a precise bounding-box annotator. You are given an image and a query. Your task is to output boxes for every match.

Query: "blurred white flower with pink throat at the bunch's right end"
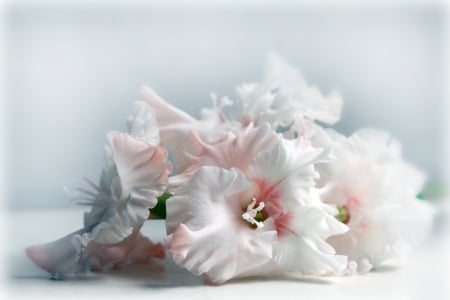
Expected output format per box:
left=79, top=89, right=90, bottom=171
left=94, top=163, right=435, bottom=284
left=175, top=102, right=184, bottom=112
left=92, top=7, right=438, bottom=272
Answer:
left=316, top=129, right=432, bottom=273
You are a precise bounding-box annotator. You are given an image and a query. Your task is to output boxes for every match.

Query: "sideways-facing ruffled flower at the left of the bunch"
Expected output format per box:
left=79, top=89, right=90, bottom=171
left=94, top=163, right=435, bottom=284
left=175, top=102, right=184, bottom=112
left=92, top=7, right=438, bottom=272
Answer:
left=78, top=132, right=171, bottom=244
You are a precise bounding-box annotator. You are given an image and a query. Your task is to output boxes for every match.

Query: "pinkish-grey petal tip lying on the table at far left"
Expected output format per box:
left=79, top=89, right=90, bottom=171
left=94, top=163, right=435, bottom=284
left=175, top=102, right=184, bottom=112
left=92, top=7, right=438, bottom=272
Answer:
left=25, top=229, right=85, bottom=278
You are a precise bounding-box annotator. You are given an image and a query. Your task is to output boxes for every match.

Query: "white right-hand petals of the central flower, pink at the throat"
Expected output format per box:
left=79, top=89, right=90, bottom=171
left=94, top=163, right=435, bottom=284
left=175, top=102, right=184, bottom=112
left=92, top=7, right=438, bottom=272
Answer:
left=248, top=138, right=347, bottom=275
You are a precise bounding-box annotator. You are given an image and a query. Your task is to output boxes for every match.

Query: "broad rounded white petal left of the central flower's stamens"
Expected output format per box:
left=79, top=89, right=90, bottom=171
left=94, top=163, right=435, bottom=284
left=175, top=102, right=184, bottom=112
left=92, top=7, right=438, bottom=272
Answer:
left=166, top=167, right=276, bottom=283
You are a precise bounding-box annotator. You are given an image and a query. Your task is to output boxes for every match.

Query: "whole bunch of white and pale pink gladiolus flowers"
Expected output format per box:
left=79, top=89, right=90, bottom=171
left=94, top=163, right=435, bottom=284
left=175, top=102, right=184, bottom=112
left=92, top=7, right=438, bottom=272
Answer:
left=26, top=55, right=433, bottom=283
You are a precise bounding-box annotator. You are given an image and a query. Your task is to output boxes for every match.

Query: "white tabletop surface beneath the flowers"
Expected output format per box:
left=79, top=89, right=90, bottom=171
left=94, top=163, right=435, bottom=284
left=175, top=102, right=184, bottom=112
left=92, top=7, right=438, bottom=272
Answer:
left=2, top=208, right=450, bottom=300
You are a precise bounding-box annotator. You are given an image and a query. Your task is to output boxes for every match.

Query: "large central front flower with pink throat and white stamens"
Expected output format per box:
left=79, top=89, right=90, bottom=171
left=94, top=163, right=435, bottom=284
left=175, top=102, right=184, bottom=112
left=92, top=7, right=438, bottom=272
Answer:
left=167, top=125, right=347, bottom=283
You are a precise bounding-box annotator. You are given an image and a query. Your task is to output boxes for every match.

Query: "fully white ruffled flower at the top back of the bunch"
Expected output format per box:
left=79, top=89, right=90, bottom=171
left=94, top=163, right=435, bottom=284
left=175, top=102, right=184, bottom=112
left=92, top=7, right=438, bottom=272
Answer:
left=220, top=55, right=342, bottom=131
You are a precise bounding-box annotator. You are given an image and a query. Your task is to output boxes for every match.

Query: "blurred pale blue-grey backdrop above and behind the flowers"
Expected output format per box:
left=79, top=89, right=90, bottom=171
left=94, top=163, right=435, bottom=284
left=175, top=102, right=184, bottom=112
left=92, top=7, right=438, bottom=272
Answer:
left=1, top=1, right=449, bottom=209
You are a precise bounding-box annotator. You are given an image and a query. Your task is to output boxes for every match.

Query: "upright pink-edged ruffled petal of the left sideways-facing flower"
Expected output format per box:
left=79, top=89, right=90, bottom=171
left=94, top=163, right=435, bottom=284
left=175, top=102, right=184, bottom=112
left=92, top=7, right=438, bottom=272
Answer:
left=108, top=132, right=171, bottom=225
